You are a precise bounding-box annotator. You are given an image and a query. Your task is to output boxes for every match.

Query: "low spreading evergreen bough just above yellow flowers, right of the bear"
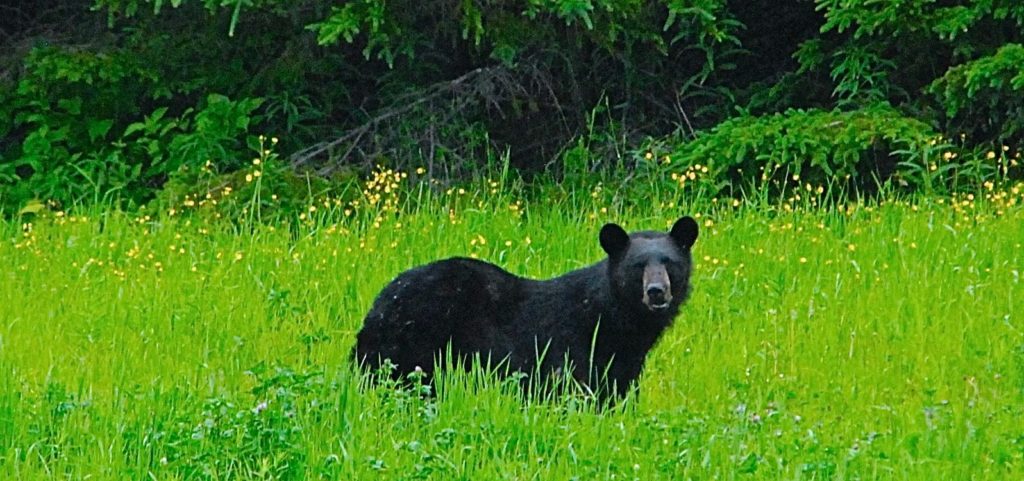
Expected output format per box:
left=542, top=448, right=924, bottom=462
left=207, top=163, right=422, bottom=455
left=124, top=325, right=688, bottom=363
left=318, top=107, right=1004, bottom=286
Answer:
left=663, top=104, right=936, bottom=195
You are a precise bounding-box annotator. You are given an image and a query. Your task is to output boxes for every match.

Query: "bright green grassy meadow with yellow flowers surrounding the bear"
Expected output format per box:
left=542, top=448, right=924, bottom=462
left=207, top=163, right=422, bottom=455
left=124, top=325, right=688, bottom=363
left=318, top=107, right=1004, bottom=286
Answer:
left=0, top=182, right=1024, bottom=480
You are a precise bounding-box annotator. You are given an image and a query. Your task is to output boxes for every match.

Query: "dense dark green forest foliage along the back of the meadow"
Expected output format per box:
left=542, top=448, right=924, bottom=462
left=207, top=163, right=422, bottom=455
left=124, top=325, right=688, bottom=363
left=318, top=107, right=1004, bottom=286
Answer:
left=0, top=0, right=1024, bottom=211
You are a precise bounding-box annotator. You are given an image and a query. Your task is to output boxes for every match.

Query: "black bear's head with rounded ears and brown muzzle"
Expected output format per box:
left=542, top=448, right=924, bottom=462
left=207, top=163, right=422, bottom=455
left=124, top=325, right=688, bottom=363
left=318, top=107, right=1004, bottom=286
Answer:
left=600, top=217, right=697, bottom=316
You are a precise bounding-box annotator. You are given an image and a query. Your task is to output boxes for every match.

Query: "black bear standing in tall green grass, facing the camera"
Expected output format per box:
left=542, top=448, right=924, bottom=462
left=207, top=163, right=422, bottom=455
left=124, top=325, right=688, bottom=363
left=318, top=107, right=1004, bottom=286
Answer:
left=353, top=217, right=697, bottom=398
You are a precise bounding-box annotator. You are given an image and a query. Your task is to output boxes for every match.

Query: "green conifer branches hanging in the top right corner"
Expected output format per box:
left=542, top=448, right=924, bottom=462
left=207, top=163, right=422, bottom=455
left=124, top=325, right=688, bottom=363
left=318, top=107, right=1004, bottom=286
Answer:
left=799, top=0, right=1024, bottom=107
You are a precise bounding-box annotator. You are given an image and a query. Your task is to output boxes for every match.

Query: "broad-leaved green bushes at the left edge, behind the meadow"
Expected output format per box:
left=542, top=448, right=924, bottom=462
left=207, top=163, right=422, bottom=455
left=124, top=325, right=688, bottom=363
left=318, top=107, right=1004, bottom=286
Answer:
left=0, top=43, right=261, bottom=208
